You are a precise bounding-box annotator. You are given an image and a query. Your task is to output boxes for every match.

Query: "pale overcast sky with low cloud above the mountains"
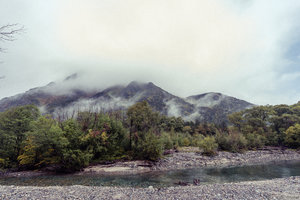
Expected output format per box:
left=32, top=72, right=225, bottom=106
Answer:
left=0, top=0, right=300, bottom=105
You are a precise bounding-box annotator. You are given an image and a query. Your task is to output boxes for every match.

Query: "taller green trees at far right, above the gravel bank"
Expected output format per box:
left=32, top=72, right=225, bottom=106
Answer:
left=229, top=102, right=300, bottom=149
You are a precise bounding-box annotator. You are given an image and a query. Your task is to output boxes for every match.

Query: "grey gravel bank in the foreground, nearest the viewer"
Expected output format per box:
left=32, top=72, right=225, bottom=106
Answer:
left=0, top=177, right=300, bottom=200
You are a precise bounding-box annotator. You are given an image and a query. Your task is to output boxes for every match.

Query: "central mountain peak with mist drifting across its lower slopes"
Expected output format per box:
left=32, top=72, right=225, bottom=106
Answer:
left=93, top=81, right=194, bottom=116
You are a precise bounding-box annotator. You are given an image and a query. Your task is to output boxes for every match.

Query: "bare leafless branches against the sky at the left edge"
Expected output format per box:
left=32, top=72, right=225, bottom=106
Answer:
left=0, top=24, right=24, bottom=52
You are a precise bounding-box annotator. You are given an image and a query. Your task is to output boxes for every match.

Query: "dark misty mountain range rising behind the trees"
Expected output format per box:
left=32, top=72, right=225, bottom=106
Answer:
left=0, top=74, right=254, bottom=123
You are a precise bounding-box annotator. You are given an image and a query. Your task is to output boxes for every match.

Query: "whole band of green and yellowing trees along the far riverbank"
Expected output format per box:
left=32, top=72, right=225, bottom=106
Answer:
left=0, top=101, right=300, bottom=172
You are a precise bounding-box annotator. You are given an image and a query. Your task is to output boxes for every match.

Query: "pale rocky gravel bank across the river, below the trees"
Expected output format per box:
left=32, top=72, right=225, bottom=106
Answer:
left=78, top=148, right=300, bottom=175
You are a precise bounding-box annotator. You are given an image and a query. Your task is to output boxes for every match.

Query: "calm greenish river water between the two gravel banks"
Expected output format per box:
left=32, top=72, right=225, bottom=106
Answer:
left=0, top=161, right=300, bottom=187
